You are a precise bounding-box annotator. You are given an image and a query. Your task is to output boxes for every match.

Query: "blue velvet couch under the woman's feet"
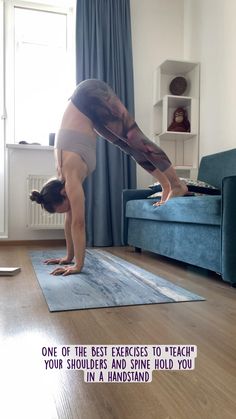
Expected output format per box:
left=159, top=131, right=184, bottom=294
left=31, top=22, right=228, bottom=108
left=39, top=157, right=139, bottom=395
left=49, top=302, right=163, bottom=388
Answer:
left=123, top=149, right=236, bottom=286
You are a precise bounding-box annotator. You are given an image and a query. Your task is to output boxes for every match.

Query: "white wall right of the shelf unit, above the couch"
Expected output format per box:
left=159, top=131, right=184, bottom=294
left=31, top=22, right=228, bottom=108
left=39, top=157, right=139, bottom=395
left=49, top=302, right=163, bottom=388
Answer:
left=184, top=0, right=236, bottom=157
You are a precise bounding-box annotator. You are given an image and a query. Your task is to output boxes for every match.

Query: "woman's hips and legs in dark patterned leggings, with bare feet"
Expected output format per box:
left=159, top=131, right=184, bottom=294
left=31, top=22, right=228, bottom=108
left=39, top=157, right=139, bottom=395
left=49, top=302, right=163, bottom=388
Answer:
left=71, top=79, right=187, bottom=202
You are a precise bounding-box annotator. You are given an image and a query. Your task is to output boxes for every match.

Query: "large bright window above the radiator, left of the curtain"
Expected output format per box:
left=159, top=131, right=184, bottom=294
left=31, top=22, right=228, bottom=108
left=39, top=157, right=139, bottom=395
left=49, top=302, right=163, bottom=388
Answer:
left=6, top=0, right=75, bottom=145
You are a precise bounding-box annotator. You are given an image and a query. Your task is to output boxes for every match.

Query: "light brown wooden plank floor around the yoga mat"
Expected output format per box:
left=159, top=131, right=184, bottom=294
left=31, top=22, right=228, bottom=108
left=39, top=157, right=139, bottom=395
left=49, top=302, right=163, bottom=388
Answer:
left=0, top=245, right=236, bottom=419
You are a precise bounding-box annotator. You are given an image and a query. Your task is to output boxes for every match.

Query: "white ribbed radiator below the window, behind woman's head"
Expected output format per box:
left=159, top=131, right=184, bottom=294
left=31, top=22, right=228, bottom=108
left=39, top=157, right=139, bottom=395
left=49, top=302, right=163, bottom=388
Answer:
left=26, top=175, right=64, bottom=230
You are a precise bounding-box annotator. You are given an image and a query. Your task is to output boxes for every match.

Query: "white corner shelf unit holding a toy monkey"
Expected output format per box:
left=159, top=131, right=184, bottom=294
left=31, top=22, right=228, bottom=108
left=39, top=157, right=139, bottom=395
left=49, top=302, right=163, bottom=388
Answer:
left=153, top=60, right=199, bottom=177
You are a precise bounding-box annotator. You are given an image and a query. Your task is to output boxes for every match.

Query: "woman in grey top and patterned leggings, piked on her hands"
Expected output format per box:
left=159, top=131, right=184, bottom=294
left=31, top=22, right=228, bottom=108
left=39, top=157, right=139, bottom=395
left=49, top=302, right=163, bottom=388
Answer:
left=30, top=79, right=187, bottom=275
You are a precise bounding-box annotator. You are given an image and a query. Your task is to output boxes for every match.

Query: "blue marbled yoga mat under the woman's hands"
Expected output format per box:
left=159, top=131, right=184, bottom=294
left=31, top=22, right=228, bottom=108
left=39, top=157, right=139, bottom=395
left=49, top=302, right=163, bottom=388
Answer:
left=30, top=249, right=205, bottom=311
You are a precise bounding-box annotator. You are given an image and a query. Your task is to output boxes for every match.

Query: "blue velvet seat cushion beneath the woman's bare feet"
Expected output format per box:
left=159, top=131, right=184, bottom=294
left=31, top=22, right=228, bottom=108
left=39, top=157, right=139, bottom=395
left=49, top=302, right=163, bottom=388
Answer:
left=126, top=195, right=221, bottom=225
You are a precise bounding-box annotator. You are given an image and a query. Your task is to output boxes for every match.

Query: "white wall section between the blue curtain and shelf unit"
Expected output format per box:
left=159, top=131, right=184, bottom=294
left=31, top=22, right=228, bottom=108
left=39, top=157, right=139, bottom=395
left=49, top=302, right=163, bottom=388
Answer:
left=130, top=0, right=184, bottom=187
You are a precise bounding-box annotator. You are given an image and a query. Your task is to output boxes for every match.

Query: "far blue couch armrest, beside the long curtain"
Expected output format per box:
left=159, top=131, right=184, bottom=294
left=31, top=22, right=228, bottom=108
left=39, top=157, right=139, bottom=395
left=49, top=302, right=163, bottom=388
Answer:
left=121, top=189, right=152, bottom=246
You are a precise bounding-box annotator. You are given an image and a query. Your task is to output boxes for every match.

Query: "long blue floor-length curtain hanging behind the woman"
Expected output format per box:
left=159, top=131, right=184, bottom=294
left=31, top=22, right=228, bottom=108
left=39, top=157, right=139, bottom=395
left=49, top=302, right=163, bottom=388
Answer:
left=76, top=0, right=136, bottom=246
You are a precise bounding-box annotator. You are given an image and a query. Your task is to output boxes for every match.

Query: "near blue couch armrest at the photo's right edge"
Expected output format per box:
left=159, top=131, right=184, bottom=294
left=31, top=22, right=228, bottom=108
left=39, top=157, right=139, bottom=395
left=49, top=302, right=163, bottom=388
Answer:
left=221, top=176, right=236, bottom=284
